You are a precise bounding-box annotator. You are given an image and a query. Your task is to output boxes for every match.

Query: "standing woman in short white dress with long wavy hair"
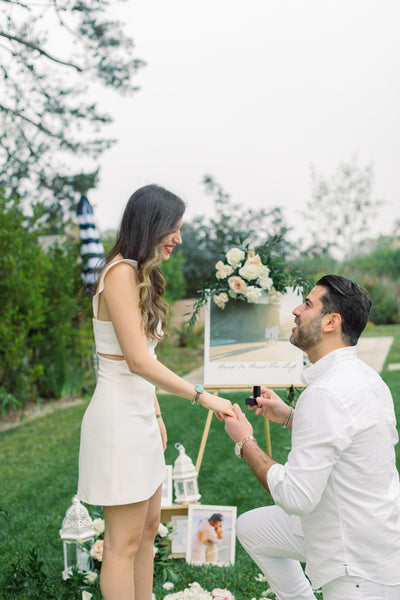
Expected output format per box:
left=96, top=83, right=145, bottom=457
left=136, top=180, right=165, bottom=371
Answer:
left=78, top=185, right=234, bottom=600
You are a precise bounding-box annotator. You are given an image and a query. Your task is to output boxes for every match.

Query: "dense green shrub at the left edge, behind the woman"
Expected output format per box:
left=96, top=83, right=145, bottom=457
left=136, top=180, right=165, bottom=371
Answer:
left=0, top=196, right=92, bottom=410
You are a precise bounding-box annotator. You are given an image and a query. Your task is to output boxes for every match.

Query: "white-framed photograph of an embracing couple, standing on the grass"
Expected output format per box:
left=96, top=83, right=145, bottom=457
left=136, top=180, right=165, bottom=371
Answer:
left=186, top=504, right=237, bottom=567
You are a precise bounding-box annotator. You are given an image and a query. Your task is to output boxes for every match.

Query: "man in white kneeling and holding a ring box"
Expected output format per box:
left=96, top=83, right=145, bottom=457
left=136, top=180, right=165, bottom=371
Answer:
left=225, top=275, right=400, bottom=600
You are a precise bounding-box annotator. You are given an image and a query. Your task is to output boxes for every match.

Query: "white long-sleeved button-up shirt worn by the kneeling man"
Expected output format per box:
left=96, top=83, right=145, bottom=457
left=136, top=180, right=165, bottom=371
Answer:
left=267, top=347, right=400, bottom=588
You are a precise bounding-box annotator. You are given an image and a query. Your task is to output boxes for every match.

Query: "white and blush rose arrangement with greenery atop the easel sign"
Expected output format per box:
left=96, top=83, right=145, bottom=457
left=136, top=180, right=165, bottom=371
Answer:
left=188, top=236, right=311, bottom=328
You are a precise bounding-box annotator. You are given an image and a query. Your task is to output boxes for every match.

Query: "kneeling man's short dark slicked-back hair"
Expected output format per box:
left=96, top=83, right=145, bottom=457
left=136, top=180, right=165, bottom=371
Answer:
left=316, top=275, right=372, bottom=346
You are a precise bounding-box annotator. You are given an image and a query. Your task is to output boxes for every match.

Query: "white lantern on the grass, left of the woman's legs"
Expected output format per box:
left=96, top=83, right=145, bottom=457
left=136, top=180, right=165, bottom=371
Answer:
left=60, top=496, right=95, bottom=579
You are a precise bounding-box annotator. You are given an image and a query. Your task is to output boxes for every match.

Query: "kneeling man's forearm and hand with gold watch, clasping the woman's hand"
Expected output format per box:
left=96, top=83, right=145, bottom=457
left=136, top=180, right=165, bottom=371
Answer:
left=225, top=404, right=276, bottom=493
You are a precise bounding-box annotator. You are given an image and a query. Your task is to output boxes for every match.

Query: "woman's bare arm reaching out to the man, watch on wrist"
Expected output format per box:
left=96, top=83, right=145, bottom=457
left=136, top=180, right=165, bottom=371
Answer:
left=103, top=263, right=234, bottom=416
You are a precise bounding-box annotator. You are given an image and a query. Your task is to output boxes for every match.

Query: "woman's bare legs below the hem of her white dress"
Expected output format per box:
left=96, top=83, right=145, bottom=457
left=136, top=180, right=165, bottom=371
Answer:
left=100, top=490, right=161, bottom=600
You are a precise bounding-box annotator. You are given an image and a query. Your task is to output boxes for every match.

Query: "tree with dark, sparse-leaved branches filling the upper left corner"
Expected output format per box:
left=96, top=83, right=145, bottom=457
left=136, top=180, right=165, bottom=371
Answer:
left=0, top=0, right=144, bottom=226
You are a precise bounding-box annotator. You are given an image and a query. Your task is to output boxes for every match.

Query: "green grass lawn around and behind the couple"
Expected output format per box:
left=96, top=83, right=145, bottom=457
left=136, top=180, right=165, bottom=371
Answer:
left=0, top=326, right=400, bottom=600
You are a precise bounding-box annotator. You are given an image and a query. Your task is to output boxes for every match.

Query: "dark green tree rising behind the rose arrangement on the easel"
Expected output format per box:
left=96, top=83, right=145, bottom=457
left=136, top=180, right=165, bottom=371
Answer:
left=181, top=175, right=291, bottom=297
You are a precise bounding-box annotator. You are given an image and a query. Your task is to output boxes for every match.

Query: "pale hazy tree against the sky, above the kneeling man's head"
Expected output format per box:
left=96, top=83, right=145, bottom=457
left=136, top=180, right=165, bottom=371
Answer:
left=302, top=158, right=383, bottom=258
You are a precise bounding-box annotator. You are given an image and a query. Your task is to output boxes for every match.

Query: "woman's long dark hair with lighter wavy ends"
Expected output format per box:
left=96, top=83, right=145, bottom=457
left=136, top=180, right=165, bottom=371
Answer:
left=101, top=184, right=186, bottom=339
